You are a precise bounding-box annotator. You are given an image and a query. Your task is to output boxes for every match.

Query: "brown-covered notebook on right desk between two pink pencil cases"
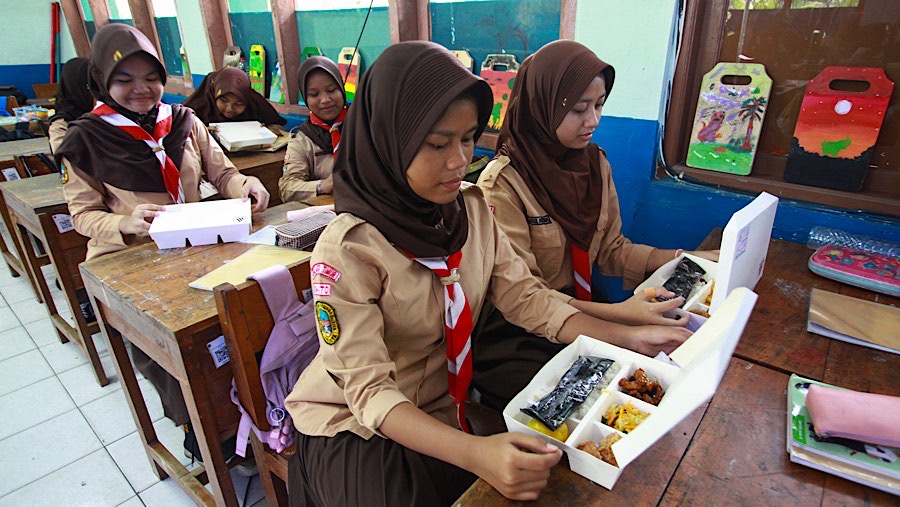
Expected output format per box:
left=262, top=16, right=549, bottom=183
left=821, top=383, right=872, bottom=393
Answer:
left=806, top=289, right=900, bottom=354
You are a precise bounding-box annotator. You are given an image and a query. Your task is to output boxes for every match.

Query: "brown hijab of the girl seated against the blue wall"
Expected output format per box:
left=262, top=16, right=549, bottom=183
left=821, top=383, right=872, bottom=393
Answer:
left=497, top=40, right=615, bottom=250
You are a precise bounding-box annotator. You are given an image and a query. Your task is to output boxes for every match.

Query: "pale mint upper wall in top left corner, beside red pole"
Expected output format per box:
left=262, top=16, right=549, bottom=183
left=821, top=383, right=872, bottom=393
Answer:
left=0, top=0, right=78, bottom=65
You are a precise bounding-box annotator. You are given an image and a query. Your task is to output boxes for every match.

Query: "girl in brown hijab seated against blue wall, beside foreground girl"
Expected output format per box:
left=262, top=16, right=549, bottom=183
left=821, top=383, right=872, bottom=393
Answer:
left=474, top=41, right=718, bottom=408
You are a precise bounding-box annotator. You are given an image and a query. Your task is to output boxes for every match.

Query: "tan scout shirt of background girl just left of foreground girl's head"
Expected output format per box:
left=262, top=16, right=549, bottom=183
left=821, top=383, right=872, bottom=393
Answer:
left=278, top=132, right=334, bottom=202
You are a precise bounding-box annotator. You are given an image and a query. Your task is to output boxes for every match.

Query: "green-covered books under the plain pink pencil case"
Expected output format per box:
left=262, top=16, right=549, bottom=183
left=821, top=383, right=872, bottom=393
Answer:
left=787, top=375, right=900, bottom=496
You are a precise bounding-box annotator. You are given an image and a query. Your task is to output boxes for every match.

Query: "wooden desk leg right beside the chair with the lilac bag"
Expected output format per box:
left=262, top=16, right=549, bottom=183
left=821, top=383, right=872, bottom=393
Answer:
left=181, top=330, right=239, bottom=507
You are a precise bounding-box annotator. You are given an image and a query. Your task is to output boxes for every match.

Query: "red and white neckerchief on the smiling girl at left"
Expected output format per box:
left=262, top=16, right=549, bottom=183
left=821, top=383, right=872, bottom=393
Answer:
left=91, top=100, right=184, bottom=204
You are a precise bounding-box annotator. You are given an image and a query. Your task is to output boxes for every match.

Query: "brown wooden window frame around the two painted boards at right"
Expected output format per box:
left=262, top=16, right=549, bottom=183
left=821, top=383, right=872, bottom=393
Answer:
left=656, top=0, right=900, bottom=216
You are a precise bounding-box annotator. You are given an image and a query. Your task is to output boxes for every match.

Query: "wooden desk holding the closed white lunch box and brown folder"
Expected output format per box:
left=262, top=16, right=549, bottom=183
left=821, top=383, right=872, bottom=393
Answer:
left=81, top=203, right=304, bottom=506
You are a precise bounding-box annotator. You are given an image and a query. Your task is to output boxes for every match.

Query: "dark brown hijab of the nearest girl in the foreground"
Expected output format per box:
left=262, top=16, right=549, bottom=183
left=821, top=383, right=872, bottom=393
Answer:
left=334, top=41, right=492, bottom=257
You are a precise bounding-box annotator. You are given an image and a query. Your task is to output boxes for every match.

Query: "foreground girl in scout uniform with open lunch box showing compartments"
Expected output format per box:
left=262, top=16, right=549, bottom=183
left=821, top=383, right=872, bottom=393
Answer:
left=286, top=41, right=689, bottom=505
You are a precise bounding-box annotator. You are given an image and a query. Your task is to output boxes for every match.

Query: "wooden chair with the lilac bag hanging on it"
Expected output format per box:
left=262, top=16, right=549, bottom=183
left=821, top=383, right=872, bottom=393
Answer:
left=213, top=259, right=310, bottom=507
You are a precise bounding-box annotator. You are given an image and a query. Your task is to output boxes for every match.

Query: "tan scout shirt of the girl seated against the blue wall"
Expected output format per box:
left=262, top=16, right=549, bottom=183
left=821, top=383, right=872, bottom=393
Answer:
left=478, top=150, right=654, bottom=290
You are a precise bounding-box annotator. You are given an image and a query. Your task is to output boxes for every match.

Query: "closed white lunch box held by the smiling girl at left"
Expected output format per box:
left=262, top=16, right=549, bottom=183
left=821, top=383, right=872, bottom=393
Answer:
left=150, top=199, right=251, bottom=248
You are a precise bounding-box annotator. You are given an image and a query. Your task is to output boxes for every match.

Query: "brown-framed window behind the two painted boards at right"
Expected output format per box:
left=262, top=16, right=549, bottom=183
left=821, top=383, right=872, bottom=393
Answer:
left=659, top=0, right=900, bottom=216
